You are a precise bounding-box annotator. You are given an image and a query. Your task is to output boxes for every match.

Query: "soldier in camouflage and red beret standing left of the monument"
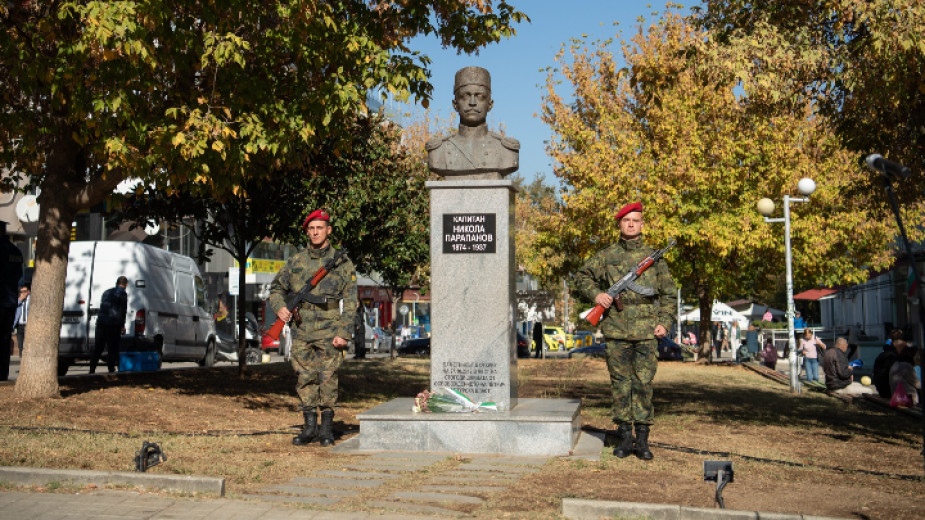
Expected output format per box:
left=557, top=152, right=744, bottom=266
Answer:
left=270, top=210, right=357, bottom=446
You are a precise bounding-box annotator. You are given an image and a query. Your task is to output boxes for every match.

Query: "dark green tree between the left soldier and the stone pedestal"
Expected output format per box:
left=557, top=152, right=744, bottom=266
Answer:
left=274, top=118, right=430, bottom=356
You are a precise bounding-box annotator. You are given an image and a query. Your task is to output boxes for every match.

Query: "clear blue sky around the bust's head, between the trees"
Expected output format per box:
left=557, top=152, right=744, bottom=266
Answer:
left=400, top=0, right=699, bottom=186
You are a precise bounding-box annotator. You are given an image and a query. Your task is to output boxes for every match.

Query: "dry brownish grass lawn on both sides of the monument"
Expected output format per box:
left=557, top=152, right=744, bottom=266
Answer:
left=0, top=359, right=925, bottom=519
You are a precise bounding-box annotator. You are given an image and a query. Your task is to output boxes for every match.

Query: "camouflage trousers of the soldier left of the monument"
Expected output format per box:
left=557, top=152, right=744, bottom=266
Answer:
left=290, top=339, right=344, bottom=410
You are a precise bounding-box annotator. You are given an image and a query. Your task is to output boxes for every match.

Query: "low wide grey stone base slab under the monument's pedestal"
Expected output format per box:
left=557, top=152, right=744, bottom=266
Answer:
left=357, top=397, right=581, bottom=457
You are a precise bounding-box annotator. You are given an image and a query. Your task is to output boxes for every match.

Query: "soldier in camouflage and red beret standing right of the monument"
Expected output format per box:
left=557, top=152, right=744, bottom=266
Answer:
left=574, top=202, right=678, bottom=460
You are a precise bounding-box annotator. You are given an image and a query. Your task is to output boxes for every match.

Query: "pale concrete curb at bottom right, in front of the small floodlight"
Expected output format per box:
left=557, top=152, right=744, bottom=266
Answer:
left=562, top=498, right=852, bottom=520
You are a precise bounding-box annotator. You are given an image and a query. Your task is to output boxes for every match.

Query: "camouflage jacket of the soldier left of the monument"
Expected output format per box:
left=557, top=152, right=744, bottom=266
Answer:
left=270, top=246, right=357, bottom=341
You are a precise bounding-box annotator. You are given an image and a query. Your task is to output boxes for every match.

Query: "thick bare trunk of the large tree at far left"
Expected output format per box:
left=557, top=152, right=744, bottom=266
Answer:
left=15, top=173, right=77, bottom=399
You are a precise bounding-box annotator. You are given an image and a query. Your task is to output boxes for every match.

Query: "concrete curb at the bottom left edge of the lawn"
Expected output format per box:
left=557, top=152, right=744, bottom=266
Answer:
left=0, top=466, right=225, bottom=496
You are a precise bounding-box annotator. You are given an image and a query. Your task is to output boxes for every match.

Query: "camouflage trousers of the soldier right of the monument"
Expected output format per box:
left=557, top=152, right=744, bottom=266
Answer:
left=606, top=338, right=658, bottom=424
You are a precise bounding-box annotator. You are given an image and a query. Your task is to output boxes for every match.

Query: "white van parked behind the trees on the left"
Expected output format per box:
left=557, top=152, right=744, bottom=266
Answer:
left=58, top=241, right=216, bottom=375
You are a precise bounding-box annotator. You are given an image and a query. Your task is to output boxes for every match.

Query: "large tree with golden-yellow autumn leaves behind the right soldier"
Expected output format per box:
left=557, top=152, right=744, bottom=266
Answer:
left=543, top=12, right=894, bottom=358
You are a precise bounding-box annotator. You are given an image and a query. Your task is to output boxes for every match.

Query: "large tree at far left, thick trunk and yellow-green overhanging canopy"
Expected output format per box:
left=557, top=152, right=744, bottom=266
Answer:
left=0, top=0, right=526, bottom=398
